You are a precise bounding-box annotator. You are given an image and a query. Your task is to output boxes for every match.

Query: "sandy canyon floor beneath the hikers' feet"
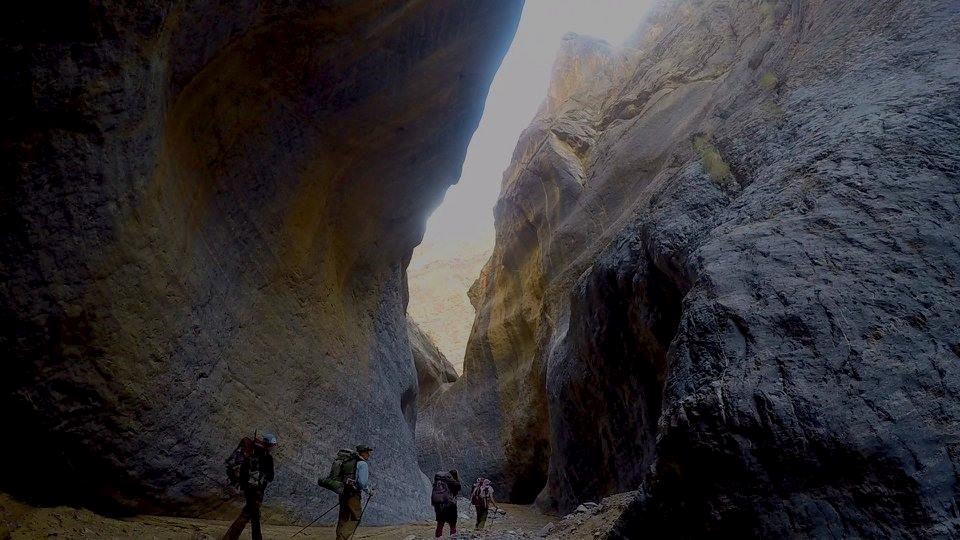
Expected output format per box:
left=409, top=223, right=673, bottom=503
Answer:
left=0, top=495, right=557, bottom=540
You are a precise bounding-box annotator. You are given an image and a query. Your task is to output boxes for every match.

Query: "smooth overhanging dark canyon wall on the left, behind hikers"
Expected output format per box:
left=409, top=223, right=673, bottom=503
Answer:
left=0, top=0, right=520, bottom=523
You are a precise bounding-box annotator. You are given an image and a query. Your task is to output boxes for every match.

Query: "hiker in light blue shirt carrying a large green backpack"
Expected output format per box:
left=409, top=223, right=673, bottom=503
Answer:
left=317, top=444, right=373, bottom=540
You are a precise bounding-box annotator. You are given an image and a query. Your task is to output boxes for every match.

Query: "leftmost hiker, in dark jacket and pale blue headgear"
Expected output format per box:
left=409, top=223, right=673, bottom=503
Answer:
left=223, top=433, right=277, bottom=540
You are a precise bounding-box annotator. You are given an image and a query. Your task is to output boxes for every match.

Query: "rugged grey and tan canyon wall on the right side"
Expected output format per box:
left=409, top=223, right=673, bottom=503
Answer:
left=418, top=0, right=960, bottom=538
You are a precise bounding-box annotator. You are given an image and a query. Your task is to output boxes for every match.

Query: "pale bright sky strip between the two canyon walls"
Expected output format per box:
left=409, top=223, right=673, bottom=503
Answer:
left=415, top=0, right=650, bottom=253
